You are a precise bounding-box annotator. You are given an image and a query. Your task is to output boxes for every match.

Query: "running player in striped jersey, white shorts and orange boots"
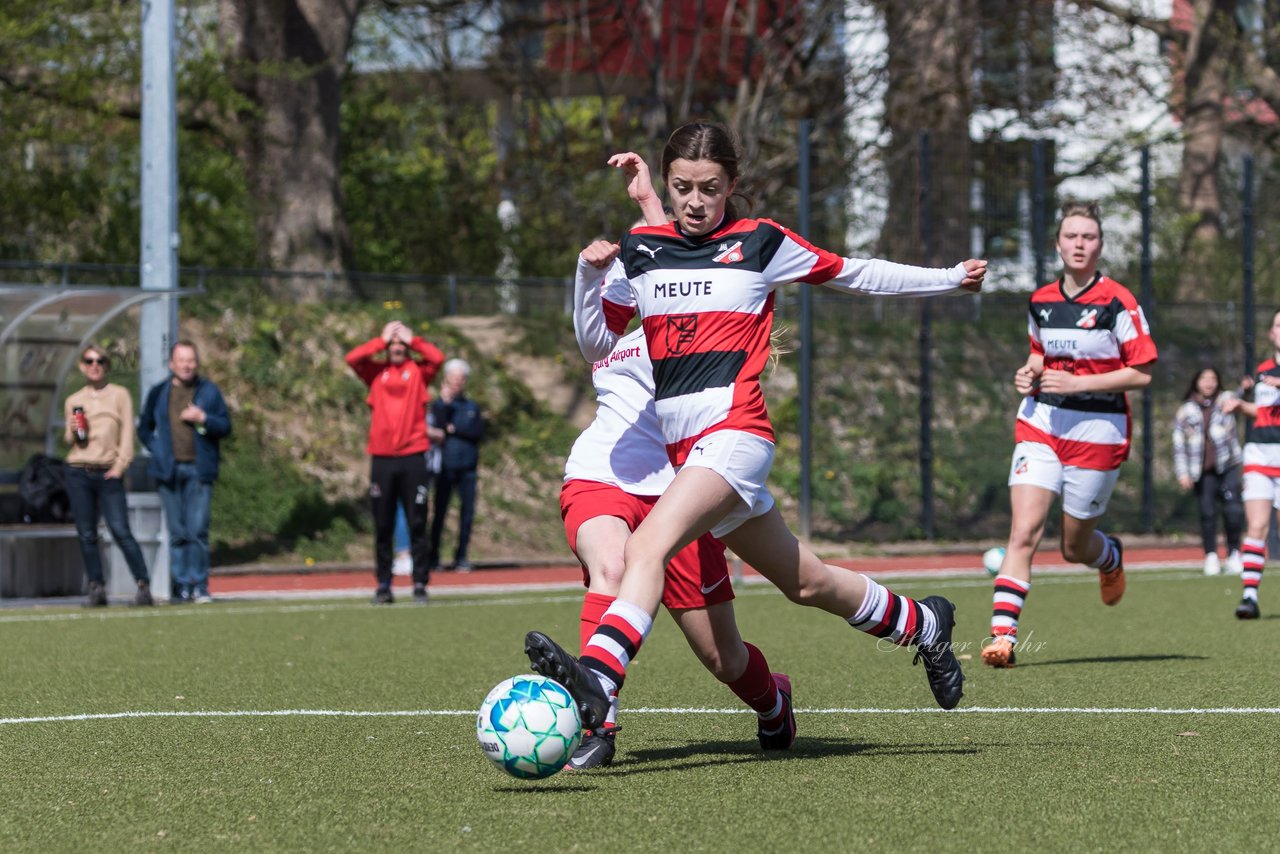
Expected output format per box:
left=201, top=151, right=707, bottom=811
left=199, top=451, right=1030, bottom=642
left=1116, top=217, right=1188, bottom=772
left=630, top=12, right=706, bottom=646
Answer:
left=982, top=202, right=1156, bottom=667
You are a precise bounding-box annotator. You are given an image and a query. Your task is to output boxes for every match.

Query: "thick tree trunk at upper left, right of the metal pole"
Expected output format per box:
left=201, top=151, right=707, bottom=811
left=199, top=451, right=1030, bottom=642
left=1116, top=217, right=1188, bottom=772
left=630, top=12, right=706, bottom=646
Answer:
left=219, top=0, right=364, bottom=297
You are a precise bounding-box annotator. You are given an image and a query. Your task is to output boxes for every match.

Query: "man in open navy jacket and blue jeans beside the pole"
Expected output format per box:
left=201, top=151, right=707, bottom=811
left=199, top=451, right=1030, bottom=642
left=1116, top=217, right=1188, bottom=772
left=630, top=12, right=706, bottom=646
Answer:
left=138, top=341, right=232, bottom=604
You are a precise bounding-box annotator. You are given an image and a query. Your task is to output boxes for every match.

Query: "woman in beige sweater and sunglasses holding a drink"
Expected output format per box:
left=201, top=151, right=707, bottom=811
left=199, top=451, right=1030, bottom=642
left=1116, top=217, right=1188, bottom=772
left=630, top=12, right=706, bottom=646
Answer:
left=63, top=344, right=154, bottom=607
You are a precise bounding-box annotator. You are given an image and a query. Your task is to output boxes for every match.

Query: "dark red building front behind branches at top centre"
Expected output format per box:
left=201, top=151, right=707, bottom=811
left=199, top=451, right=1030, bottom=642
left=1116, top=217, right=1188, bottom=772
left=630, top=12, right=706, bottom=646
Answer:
left=544, top=0, right=803, bottom=87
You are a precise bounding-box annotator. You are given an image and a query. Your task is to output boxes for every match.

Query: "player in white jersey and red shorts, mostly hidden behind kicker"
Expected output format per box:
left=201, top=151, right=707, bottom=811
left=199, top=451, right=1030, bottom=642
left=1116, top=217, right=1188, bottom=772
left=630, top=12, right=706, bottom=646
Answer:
left=561, top=322, right=796, bottom=769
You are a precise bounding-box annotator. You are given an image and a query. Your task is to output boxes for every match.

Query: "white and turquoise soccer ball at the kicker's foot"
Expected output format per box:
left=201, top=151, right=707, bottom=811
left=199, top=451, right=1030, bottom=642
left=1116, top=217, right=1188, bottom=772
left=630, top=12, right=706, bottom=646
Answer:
left=476, top=673, right=582, bottom=780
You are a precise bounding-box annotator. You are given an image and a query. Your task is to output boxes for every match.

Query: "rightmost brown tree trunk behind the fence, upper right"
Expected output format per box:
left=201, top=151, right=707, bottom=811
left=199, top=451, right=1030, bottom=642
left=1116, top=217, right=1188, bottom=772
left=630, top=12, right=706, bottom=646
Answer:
left=1175, top=0, right=1235, bottom=300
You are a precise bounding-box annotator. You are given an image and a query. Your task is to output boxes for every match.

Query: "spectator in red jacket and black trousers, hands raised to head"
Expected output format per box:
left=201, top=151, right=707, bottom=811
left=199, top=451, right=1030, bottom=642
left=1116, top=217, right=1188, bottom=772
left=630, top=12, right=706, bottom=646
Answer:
left=347, top=320, right=444, bottom=604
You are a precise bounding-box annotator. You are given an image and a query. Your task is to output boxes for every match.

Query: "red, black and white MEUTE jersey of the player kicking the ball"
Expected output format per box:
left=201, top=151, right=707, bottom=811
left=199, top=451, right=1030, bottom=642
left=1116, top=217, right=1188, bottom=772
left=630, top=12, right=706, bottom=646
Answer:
left=593, top=219, right=965, bottom=465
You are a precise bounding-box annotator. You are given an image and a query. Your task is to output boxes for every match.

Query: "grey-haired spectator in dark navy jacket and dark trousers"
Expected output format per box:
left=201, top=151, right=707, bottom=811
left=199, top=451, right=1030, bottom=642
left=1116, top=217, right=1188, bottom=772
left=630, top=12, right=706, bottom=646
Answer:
left=428, top=359, right=485, bottom=572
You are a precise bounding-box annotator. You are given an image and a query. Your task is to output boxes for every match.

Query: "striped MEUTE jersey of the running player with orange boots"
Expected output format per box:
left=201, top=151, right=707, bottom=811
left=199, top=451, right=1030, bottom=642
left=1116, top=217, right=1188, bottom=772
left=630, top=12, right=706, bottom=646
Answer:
left=1015, top=273, right=1156, bottom=470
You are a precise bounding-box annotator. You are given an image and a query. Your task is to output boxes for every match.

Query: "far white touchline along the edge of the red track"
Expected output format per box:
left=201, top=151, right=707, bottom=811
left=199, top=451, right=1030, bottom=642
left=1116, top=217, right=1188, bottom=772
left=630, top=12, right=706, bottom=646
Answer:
left=0, top=565, right=1213, bottom=625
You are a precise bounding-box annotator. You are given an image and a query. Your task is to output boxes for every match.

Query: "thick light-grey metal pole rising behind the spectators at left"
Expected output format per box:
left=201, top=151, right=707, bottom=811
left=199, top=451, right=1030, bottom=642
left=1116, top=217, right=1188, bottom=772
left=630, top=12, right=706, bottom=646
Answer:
left=140, top=0, right=178, bottom=394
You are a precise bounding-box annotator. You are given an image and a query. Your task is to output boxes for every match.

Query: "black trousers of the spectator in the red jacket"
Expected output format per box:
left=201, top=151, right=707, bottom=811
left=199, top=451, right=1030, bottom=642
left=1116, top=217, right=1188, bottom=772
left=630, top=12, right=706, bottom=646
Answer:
left=369, top=453, right=430, bottom=586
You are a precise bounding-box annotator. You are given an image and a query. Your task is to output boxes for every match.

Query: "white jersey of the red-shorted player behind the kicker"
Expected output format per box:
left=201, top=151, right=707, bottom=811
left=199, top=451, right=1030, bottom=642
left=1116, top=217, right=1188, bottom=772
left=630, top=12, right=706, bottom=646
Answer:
left=564, top=328, right=676, bottom=495
